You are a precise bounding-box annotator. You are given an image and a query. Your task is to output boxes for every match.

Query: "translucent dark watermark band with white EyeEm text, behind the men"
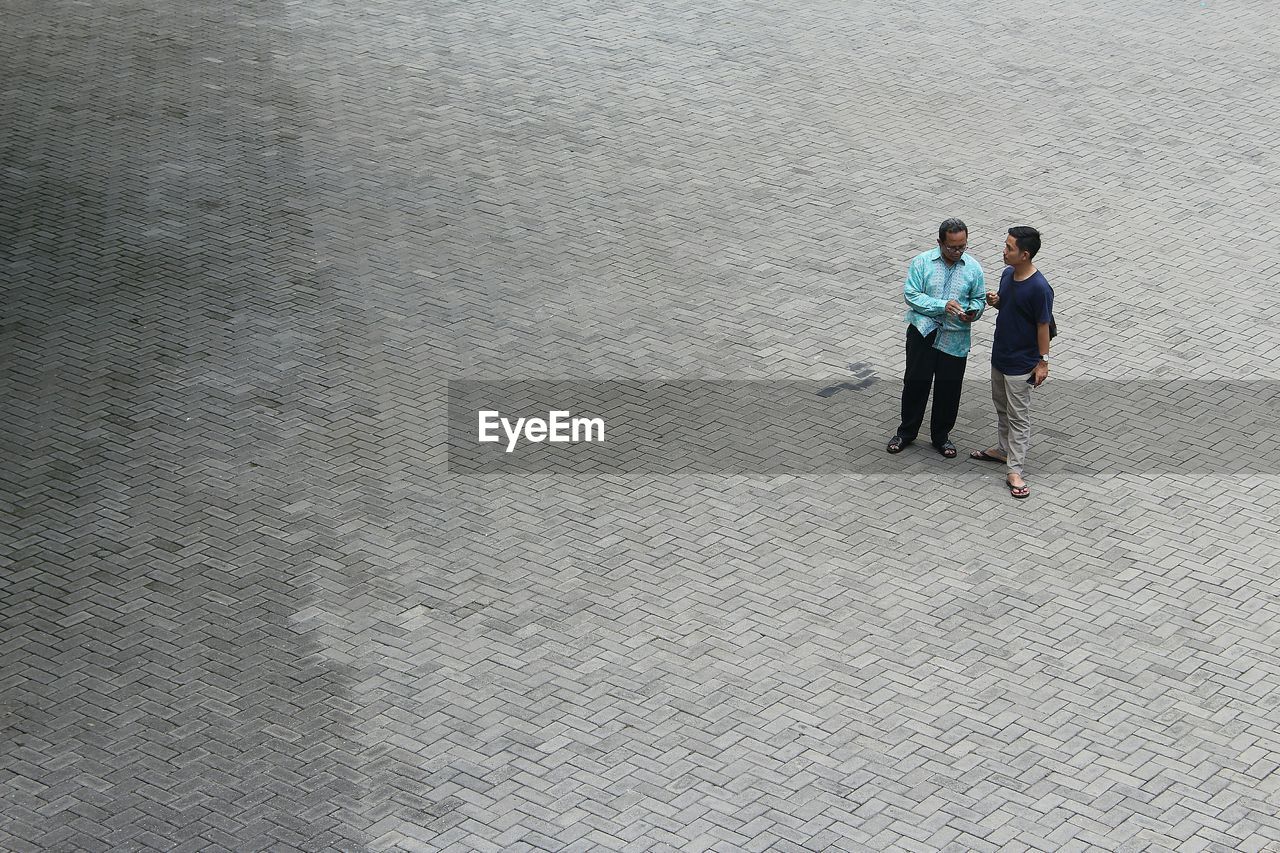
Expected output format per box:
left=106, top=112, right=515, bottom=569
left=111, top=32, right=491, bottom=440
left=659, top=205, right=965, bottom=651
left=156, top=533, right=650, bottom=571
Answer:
left=447, top=371, right=1280, bottom=476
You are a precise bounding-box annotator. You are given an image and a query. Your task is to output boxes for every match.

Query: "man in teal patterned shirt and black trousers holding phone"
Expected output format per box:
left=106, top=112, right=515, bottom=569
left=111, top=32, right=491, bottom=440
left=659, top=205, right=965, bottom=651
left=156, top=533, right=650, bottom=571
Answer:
left=886, top=219, right=986, bottom=459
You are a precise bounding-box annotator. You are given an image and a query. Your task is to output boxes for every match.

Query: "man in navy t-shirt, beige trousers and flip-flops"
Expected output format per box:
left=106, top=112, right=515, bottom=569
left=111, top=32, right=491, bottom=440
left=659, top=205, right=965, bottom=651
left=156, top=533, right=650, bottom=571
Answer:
left=969, top=225, right=1053, bottom=498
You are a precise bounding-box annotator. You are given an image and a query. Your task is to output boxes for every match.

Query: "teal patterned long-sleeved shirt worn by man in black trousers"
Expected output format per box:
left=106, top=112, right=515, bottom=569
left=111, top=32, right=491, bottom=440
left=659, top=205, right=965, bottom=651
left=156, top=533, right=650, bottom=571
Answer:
left=902, top=248, right=987, bottom=359
